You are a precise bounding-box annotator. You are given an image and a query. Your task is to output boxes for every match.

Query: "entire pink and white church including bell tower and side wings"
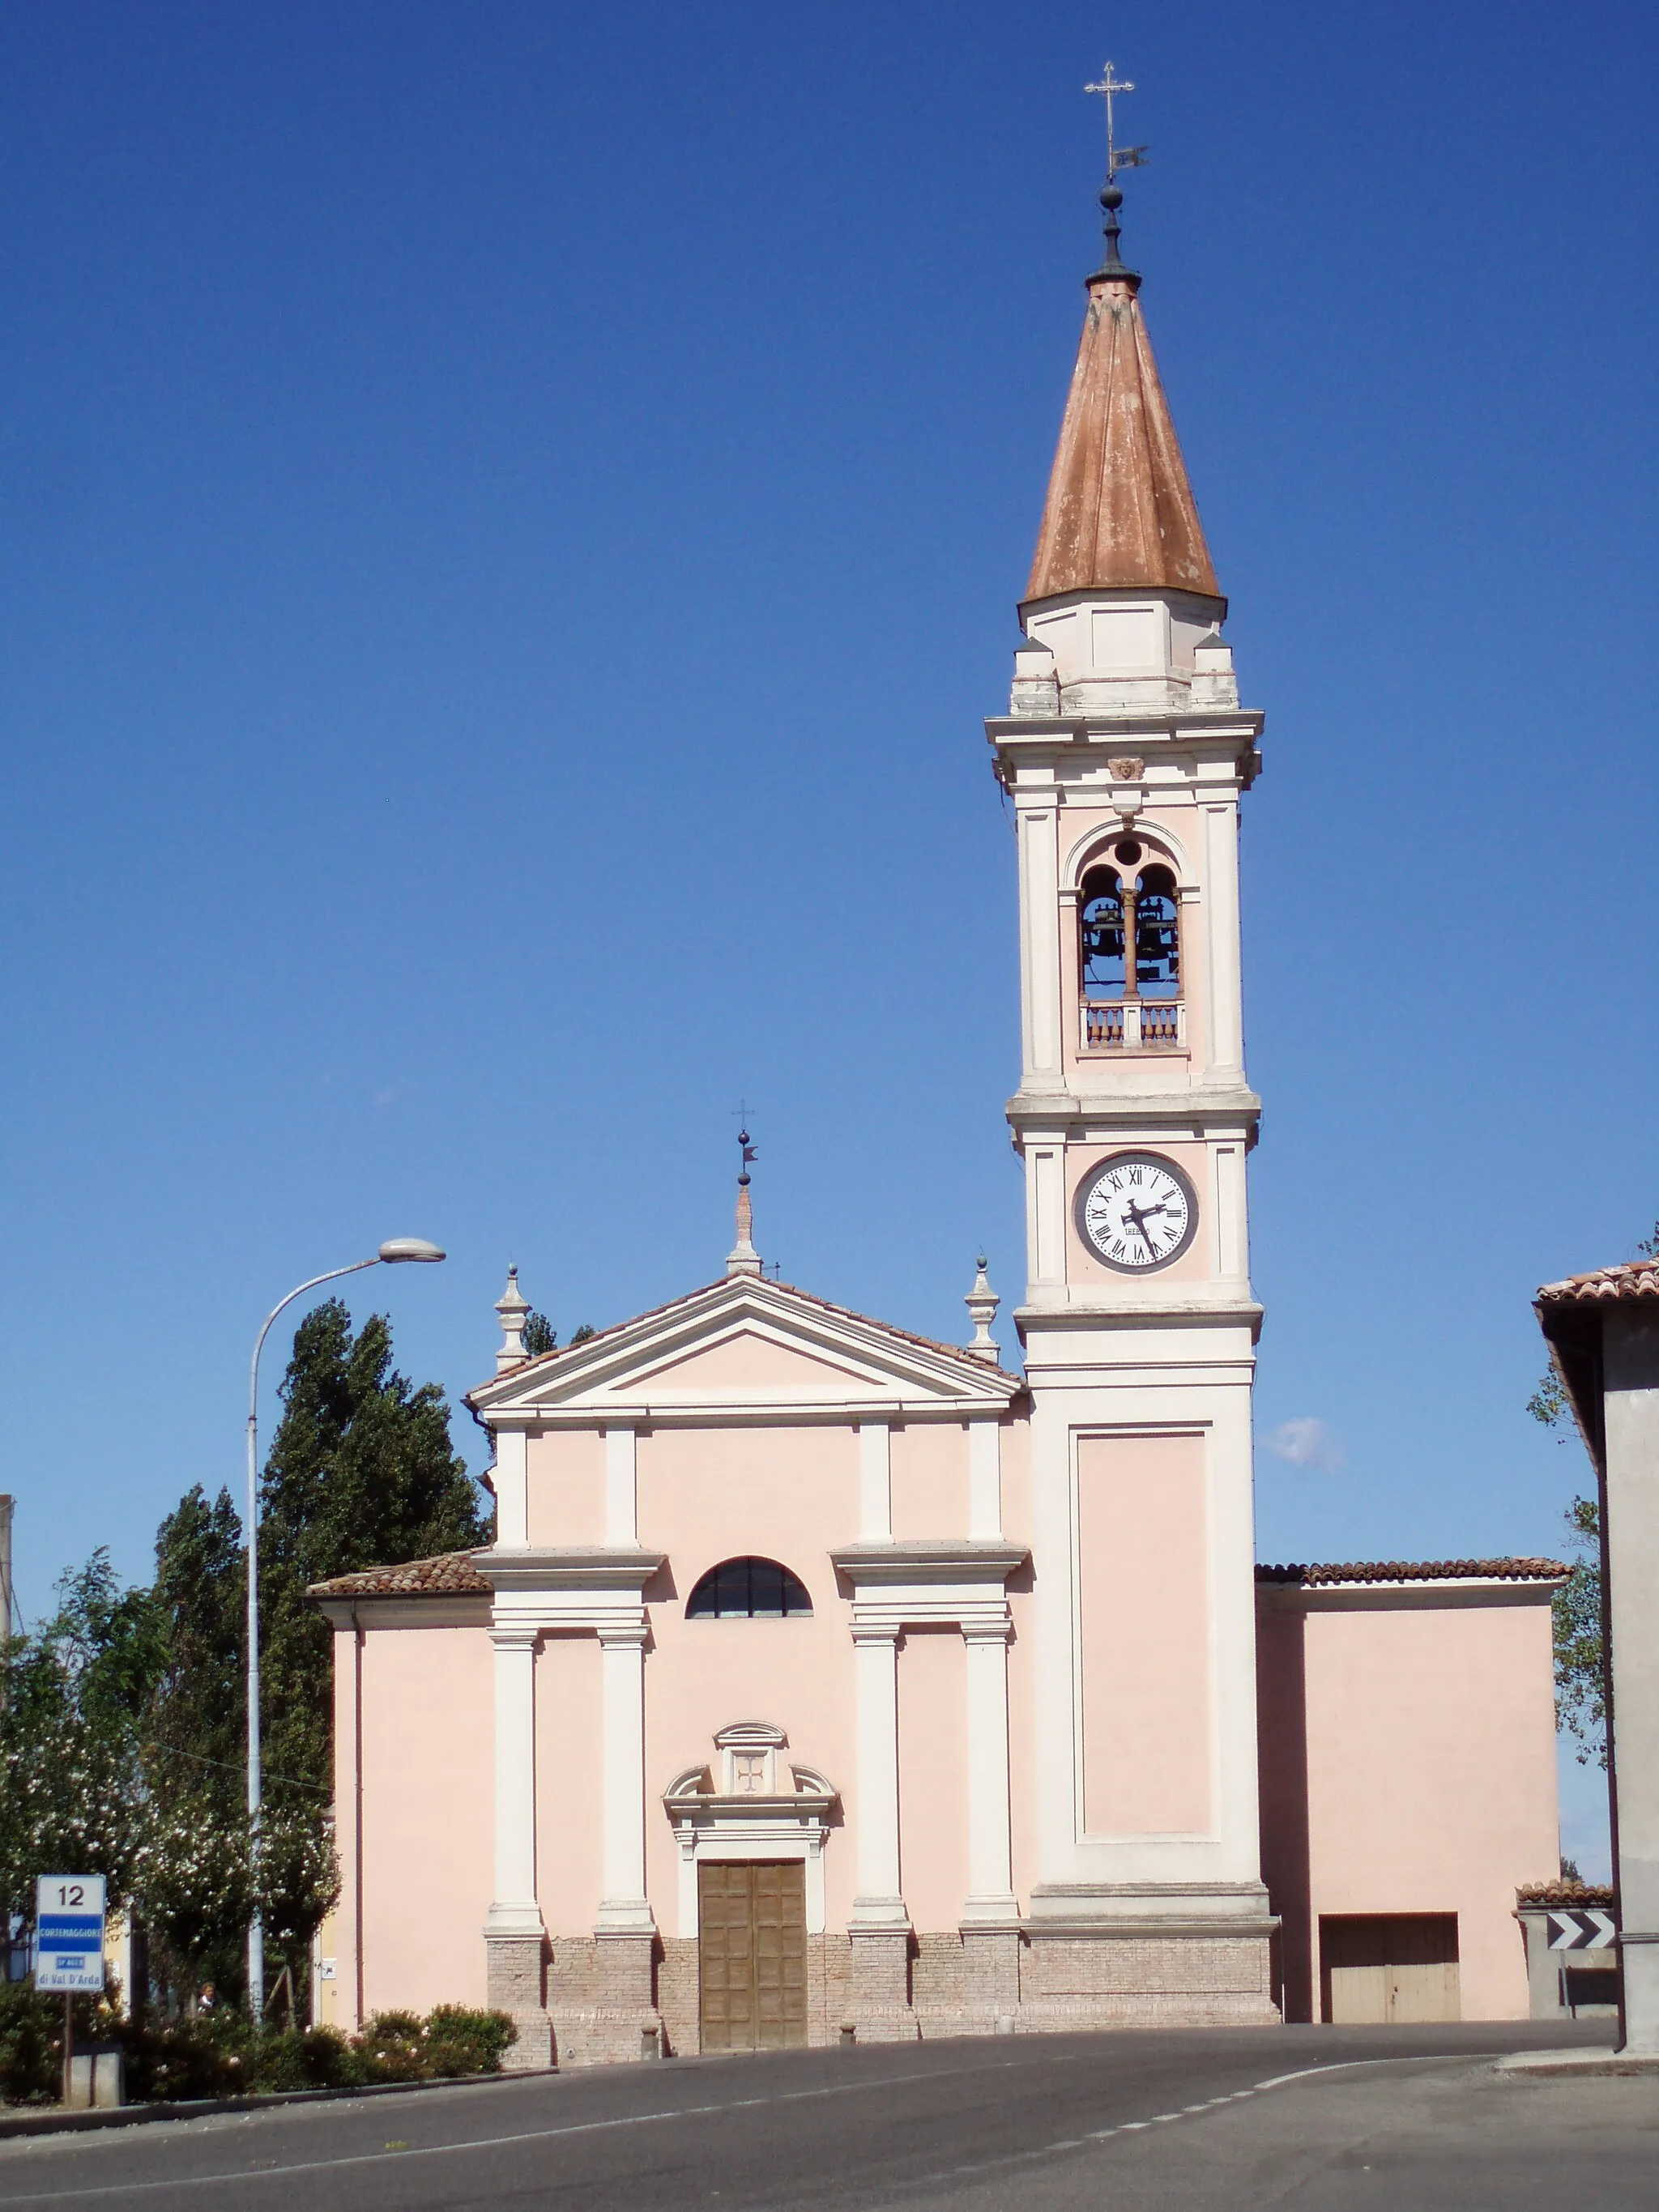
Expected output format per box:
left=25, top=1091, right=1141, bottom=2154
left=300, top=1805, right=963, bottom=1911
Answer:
left=314, top=194, right=1559, bottom=2064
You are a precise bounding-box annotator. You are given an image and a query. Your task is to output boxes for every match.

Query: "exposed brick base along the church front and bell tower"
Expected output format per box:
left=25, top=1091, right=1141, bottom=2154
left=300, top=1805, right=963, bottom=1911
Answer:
left=526, top=1929, right=1278, bottom=2066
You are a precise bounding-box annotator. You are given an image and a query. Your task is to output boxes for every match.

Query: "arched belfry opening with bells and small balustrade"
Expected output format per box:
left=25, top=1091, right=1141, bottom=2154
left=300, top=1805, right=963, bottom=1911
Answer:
left=1077, top=836, right=1186, bottom=1053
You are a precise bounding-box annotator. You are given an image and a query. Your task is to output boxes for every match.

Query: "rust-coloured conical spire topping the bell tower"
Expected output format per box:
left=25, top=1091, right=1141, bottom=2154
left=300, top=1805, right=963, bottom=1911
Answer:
left=1026, top=179, right=1221, bottom=599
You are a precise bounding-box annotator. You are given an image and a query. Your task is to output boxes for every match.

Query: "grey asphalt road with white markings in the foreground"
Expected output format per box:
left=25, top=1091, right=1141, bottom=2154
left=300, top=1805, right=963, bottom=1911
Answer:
left=0, top=2022, right=1659, bottom=2212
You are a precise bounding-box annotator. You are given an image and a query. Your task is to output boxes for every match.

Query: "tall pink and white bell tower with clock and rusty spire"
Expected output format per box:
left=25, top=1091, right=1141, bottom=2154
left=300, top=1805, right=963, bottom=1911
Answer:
left=987, top=173, right=1274, bottom=2019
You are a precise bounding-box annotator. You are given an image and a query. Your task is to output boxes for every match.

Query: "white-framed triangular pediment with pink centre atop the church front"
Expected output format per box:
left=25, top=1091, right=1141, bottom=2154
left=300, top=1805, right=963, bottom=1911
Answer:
left=469, top=1276, right=1020, bottom=1420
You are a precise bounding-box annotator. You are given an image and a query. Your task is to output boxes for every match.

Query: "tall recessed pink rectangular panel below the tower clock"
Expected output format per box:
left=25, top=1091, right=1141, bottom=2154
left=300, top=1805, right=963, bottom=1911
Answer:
left=1077, top=1435, right=1210, bottom=1836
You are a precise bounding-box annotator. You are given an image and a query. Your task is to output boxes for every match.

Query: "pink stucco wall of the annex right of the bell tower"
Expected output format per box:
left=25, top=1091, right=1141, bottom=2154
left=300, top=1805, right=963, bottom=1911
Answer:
left=1259, top=1583, right=1559, bottom=2019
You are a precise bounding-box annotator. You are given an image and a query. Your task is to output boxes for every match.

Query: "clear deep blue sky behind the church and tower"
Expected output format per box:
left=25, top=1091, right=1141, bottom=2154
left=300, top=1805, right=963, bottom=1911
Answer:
left=0, top=0, right=1659, bottom=1866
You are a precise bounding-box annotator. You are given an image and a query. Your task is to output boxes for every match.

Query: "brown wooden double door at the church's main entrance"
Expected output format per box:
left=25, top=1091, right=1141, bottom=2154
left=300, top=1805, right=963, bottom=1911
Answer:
left=697, top=1858, right=808, bottom=2051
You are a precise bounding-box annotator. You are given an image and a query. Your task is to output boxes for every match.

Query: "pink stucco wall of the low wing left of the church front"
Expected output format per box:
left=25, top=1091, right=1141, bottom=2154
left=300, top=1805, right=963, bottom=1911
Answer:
left=353, top=1626, right=493, bottom=2013
